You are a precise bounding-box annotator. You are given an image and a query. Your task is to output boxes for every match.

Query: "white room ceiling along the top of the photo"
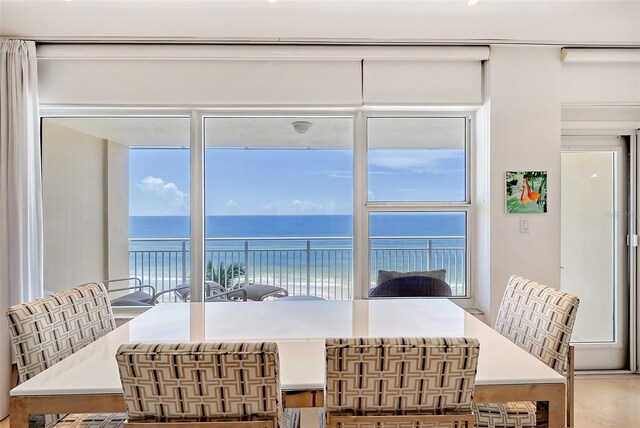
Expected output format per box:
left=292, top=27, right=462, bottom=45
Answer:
left=5, top=0, right=640, bottom=46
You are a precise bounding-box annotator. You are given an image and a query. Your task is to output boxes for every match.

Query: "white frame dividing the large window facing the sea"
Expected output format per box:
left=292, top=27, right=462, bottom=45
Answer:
left=39, top=105, right=476, bottom=311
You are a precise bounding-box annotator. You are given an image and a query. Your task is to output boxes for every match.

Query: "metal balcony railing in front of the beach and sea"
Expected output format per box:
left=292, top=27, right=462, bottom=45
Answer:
left=129, top=236, right=466, bottom=300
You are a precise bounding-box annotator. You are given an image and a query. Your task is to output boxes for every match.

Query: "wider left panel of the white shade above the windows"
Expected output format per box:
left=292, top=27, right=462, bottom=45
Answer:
left=38, top=59, right=360, bottom=106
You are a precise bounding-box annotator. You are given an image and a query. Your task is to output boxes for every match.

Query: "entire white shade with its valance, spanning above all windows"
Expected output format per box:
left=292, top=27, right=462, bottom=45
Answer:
left=38, top=44, right=489, bottom=106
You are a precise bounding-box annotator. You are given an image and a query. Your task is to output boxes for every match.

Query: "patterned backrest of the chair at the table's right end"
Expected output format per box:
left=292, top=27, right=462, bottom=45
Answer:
left=495, top=275, right=580, bottom=374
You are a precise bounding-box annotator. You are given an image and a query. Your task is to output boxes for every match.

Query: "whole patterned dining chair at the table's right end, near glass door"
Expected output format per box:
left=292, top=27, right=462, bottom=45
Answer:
left=474, top=275, right=580, bottom=428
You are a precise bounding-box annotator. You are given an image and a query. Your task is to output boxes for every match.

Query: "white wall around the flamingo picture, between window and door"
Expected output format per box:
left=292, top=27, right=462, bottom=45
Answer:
left=478, top=45, right=561, bottom=324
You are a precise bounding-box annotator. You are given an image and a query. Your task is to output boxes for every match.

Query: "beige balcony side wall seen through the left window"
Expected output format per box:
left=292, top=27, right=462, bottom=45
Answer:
left=42, top=120, right=107, bottom=292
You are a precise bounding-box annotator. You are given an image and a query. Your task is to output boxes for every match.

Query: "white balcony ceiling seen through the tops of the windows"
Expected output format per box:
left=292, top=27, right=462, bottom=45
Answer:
left=44, top=116, right=466, bottom=148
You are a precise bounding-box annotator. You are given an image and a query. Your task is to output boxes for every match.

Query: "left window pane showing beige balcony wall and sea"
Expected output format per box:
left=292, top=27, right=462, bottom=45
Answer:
left=42, top=117, right=190, bottom=305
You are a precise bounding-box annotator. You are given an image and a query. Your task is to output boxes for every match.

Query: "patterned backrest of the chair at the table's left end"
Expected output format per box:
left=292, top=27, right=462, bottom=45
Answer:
left=7, top=283, right=115, bottom=382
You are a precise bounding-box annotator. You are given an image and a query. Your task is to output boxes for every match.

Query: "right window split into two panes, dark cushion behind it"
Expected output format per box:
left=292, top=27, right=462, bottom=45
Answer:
left=367, top=117, right=470, bottom=296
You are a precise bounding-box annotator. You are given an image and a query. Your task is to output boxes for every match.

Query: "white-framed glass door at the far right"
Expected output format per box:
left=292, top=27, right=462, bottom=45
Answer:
left=561, top=136, right=635, bottom=369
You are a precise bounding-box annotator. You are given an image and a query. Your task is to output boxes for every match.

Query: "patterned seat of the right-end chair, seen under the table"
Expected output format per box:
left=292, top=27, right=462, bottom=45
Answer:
left=473, top=401, right=536, bottom=428
